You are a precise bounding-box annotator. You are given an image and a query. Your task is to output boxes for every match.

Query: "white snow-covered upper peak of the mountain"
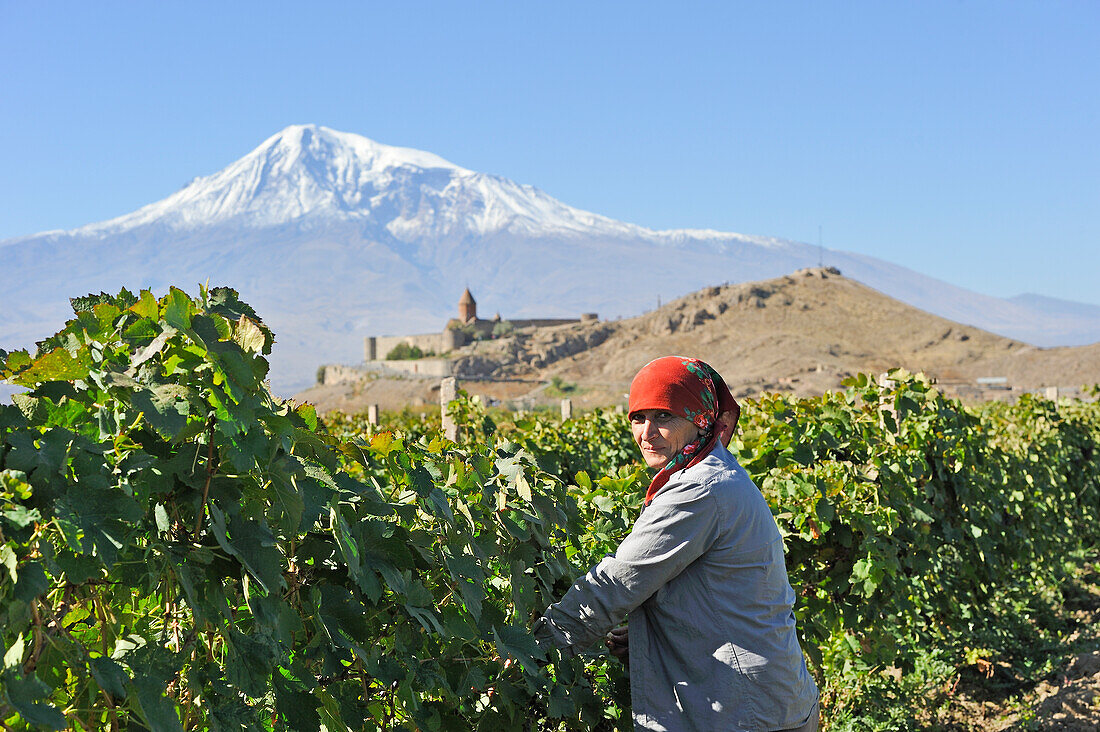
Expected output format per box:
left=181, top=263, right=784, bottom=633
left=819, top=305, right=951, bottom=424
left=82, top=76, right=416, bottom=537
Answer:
left=73, top=124, right=642, bottom=239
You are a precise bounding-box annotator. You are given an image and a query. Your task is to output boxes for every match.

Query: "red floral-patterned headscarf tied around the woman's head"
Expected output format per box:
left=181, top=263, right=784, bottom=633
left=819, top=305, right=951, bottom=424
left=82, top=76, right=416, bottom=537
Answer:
left=629, top=356, right=741, bottom=505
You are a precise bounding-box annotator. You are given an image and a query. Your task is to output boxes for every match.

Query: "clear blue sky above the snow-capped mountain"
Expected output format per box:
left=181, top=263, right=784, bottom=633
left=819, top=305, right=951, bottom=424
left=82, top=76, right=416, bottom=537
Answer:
left=0, top=0, right=1100, bottom=304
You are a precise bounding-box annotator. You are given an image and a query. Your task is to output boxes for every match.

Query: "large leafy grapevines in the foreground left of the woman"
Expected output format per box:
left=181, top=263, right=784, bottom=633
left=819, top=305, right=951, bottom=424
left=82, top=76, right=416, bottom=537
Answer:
left=0, top=288, right=623, bottom=732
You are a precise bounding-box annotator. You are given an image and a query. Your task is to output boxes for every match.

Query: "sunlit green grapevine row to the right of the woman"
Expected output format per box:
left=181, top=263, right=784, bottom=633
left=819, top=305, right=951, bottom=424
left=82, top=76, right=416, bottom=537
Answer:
left=734, top=370, right=1100, bottom=695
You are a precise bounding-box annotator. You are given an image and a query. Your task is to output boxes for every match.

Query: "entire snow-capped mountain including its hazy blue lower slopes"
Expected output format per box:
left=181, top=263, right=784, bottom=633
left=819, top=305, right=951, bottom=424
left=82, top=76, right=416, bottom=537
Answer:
left=0, top=125, right=1100, bottom=393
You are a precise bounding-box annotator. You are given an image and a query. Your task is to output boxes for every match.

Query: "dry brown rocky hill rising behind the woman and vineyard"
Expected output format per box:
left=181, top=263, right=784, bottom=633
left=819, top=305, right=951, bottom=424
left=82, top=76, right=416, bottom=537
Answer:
left=300, top=269, right=1100, bottom=408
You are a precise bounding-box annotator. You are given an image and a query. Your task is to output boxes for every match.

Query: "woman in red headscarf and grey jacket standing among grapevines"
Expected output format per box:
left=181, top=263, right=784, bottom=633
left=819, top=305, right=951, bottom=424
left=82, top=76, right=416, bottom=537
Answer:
left=535, top=357, right=818, bottom=732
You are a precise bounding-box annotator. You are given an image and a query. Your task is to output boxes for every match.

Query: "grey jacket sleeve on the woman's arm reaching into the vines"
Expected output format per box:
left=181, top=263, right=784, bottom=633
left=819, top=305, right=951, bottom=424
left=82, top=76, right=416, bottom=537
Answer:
left=534, top=484, right=718, bottom=656
